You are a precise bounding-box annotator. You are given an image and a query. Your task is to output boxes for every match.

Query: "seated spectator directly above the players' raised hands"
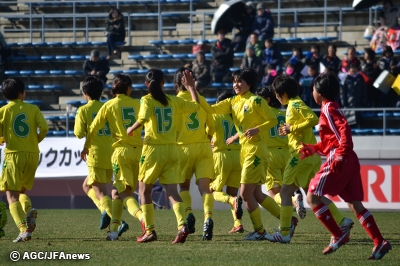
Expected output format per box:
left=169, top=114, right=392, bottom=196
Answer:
left=192, top=51, right=211, bottom=90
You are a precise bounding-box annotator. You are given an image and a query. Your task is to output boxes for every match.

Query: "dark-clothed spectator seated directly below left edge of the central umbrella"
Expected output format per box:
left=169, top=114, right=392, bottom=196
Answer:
left=211, top=30, right=233, bottom=82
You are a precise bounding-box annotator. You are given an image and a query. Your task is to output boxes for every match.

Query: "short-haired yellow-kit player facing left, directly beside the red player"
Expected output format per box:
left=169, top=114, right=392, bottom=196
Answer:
left=265, top=75, right=350, bottom=243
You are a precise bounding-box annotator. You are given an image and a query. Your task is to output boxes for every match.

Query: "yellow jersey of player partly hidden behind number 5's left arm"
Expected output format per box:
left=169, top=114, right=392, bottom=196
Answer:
left=74, top=100, right=112, bottom=169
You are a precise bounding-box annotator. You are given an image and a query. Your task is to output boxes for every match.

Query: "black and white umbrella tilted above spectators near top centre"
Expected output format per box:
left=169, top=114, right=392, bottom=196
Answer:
left=211, top=0, right=246, bottom=34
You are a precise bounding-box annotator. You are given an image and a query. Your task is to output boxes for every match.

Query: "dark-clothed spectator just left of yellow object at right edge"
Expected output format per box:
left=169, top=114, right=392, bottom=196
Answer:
left=360, top=48, right=383, bottom=107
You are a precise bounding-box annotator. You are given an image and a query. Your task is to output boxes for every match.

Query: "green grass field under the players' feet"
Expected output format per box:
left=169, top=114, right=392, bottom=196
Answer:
left=0, top=209, right=400, bottom=265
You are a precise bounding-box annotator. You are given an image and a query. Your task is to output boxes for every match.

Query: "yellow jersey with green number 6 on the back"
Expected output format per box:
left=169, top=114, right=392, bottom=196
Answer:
left=0, top=99, right=49, bottom=153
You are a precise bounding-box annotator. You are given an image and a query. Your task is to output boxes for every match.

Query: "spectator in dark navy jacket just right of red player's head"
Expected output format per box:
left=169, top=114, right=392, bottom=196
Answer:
left=340, top=64, right=367, bottom=128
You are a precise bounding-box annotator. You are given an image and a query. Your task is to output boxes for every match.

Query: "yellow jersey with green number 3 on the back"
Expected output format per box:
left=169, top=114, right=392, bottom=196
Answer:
left=177, top=91, right=214, bottom=145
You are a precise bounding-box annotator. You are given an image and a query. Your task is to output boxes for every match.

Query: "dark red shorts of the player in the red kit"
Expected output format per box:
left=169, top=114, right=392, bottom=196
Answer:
left=308, top=150, right=364, bottom=202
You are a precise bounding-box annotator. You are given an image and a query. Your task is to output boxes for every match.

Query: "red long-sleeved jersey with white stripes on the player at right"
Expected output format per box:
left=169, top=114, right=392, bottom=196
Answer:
left=315, top=100, right=353, bottom=157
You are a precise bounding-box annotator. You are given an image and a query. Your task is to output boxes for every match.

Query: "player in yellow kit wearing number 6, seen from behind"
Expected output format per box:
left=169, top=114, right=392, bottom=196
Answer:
left=0, top=78, right=49, bottom=242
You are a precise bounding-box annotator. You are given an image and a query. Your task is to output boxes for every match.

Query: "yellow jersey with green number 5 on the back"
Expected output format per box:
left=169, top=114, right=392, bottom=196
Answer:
left=85, top=94, right=143, bottom=149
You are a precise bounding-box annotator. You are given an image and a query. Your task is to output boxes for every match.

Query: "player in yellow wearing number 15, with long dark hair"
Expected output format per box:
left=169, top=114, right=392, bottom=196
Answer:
left=127, top=68, right=199, bottom=244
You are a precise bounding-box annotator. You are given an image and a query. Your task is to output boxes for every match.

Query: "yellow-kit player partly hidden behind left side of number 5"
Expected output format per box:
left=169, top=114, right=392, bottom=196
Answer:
left=74, top=76, right=127, bottom=234
